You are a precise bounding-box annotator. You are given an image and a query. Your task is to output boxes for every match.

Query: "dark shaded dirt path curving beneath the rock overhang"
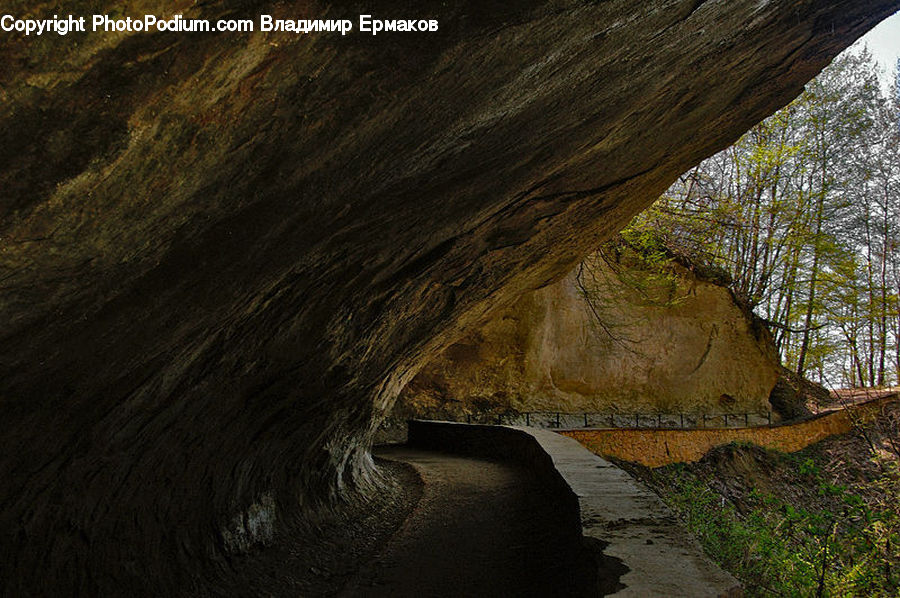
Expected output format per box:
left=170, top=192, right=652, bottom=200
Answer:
left=340, top=447, right=588, bottom=597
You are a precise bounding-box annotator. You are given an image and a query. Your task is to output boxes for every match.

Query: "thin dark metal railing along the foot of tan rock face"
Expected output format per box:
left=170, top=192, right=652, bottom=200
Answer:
left=465, top=411, right=772, bottom=430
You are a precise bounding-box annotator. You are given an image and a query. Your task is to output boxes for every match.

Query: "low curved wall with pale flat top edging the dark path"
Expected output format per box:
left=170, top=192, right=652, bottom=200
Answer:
left=408, top=420, right=741, bottom=598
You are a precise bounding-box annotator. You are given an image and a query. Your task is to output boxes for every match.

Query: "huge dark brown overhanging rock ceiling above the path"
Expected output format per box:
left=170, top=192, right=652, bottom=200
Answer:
left=0, top=0, right=900, bottom=595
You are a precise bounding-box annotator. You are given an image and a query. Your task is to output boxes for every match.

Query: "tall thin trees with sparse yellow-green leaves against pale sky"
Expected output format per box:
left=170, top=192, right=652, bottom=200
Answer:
left=623, top=51, right=900, bottom=386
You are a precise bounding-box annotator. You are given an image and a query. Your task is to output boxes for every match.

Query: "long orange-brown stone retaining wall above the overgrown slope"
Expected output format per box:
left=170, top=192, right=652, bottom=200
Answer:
left=559, top=394, right=897, bottom=467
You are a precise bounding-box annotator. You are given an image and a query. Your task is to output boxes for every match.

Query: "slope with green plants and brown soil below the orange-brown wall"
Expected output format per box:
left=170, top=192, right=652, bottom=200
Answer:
left=626, top=422, right=900, bottom=596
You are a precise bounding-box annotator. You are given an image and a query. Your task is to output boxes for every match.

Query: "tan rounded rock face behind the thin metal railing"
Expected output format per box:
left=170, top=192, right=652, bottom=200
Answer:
left=395, top=245, right=780, bottom=418
